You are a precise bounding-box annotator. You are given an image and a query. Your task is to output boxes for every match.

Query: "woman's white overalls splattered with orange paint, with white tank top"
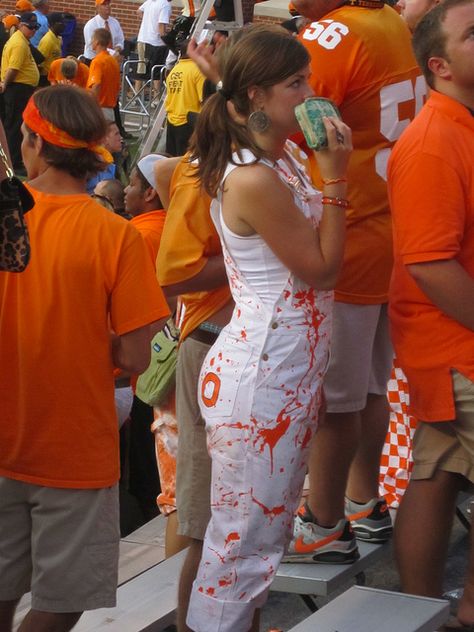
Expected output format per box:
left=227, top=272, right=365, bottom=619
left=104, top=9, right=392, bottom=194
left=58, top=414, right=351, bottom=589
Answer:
left=187, top=144, right=332, bottom=632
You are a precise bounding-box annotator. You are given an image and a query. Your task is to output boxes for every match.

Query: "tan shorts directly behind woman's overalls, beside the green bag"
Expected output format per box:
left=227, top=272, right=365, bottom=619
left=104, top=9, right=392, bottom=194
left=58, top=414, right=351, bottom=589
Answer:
left=176, top=337, right=211, bottom=540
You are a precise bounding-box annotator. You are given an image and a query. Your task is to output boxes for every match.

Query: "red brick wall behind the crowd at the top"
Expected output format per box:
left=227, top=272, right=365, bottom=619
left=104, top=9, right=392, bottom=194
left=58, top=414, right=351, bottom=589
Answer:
left=2, top=0, right=272, bottom=55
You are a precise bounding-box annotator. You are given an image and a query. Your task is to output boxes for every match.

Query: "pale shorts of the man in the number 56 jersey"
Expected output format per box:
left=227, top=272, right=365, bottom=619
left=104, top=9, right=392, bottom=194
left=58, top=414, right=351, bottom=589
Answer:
left=324, top=302, right=393, bottom=413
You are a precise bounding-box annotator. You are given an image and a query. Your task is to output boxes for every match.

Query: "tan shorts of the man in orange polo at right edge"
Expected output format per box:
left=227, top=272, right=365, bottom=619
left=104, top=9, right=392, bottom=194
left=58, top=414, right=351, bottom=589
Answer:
left=412, top=370, right=474, bottom=483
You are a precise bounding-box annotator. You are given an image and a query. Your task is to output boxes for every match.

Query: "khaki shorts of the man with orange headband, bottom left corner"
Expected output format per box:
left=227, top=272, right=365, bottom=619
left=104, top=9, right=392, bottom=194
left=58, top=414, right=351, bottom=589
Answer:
left=0, top=477, right=120, bottom=612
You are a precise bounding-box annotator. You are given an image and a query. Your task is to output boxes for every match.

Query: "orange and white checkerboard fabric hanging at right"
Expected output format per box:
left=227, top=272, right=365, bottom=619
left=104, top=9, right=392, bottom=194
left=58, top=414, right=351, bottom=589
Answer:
left=380, top=358, right=416, bottom=508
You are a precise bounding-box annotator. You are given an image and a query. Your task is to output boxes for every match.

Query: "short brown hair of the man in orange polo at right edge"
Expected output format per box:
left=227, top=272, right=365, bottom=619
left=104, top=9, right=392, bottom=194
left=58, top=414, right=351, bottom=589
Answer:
left=412, top=0, right=473, bottom=88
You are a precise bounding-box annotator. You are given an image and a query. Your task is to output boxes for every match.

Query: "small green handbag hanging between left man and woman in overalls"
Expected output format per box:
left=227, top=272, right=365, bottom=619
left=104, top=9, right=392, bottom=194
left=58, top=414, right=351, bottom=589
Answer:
left=135, top=318, right=179, bottom=406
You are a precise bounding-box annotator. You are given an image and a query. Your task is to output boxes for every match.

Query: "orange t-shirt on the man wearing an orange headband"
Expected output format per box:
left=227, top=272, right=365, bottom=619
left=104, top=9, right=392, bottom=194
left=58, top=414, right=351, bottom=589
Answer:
left=0, top=189, right=169, bottom=489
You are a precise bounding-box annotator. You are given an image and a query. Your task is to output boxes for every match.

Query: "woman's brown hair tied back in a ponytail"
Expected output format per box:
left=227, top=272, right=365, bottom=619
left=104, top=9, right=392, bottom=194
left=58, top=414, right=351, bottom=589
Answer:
left=191, top=25, right=310, bottom=197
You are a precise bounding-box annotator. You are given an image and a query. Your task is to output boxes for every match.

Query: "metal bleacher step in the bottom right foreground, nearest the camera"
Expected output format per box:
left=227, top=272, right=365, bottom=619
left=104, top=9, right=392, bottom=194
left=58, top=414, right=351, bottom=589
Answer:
left=290, top=586, right=449, bottom=632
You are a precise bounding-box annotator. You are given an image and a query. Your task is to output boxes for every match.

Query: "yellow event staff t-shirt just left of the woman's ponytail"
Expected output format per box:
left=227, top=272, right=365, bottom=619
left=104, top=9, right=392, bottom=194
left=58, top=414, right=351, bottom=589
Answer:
left=165, top=59, right=205, bottom=125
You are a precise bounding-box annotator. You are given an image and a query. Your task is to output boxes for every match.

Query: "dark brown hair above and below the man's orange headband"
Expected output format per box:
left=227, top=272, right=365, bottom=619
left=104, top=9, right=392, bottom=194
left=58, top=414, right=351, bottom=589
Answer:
left=28, top=85, right=107, bottom=178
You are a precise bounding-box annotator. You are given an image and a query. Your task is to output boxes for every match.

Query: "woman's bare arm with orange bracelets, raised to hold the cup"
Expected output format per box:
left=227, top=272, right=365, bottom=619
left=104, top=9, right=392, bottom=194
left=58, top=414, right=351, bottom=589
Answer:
left=223, top=119, right=352, bottom=290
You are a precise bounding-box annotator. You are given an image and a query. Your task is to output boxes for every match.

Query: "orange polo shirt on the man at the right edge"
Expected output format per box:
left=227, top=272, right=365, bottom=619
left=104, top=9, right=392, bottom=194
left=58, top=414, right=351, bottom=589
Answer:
left=388, top=91, right=474, bottom=421
